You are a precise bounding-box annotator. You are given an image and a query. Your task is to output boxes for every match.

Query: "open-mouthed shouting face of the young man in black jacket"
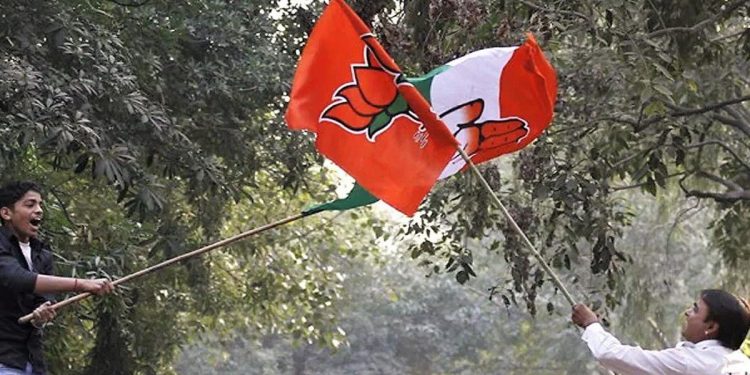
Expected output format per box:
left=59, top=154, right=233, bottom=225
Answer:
left=0, top=190, right=43, bottom=242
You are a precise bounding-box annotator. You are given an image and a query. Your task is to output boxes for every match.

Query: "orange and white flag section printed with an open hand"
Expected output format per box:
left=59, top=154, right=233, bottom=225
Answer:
left=418, top=34, right=557, bottom=178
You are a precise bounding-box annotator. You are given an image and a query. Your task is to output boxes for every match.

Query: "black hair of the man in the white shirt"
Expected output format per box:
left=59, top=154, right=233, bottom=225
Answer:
left=701, top=289, right=750, bottom=350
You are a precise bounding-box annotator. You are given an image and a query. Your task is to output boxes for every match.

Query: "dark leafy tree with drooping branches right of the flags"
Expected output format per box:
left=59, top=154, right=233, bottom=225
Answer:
left=374, top=0, right=750, bottom=311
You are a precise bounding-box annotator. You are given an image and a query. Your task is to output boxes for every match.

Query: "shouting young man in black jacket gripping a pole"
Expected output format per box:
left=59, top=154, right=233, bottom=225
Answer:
left=0, top=182, right=112, bottom=375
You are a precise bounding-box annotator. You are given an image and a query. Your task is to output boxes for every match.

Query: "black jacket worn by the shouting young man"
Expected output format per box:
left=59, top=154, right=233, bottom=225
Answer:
left=0, top=227, right=52, bottom=374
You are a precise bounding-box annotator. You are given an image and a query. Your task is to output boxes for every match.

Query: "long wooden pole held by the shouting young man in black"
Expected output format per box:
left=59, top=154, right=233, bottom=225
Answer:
left=18, top=211, right=322, bottom=323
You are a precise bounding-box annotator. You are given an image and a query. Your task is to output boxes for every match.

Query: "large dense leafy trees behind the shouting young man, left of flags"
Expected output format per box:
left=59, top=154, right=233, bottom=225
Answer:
left=0, top=0, right=364, bottom=374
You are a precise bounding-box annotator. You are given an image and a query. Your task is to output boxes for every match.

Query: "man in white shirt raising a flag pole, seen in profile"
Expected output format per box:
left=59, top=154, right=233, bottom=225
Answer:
left=572, top=289, right=750, bottom=375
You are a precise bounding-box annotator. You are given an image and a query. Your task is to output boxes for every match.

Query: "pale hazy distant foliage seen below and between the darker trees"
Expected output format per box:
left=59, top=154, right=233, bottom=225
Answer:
left=176, top=173, right=748, bottom=375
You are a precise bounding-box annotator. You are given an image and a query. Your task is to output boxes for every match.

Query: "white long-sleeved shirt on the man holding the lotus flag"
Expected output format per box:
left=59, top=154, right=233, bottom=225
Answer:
left=582, top=323, right=732, bottom=375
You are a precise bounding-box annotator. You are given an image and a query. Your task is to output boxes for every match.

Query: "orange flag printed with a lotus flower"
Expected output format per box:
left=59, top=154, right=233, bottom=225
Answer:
left=285, top=0, right=458, bottom=215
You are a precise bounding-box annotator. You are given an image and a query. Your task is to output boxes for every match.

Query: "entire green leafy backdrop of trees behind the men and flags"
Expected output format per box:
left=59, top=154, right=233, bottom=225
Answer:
left=0, top=0, right=750, bottom=374
